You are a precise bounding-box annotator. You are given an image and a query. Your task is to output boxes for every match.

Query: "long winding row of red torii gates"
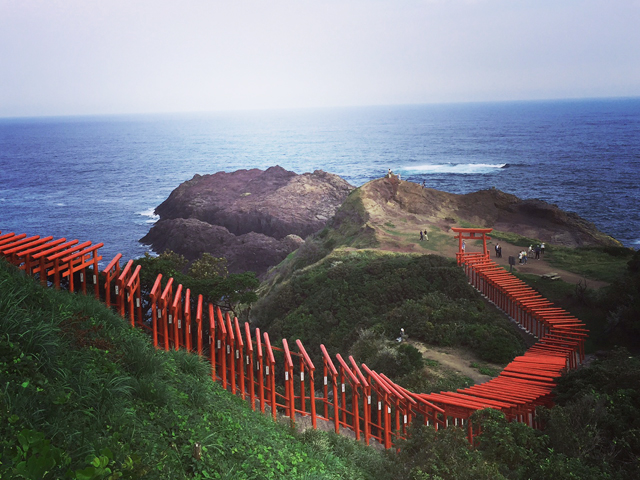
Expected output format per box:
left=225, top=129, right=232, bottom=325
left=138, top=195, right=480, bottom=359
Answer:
left=0, top=228, right=587, bottom=448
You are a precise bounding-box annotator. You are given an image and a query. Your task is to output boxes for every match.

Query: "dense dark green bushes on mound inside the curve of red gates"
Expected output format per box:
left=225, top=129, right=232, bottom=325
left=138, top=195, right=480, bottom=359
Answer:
left=252, top=251, right=524, bottom=378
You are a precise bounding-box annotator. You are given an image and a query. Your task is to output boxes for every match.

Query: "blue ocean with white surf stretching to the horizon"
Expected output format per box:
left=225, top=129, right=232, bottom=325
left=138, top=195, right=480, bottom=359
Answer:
left=0, top=98, right=640, bottom=260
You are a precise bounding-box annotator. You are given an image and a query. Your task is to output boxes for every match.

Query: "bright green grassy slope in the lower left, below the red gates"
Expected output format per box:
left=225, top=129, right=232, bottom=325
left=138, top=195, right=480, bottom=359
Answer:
left=0, top=261, right=389, bottom=479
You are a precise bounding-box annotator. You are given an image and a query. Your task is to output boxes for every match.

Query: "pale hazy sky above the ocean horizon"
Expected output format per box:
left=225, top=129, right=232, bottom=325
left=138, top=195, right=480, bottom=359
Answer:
left=0, top=0, right=640, bottom=117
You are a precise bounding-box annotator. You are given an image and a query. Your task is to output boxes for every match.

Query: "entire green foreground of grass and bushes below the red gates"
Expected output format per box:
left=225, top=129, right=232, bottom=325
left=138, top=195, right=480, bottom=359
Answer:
left=0, top=253, right=640, bottom=480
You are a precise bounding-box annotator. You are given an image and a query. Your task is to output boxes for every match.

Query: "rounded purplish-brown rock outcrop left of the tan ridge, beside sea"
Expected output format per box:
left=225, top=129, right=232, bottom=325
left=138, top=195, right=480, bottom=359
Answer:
left=140, top=166, right=354, bottom=274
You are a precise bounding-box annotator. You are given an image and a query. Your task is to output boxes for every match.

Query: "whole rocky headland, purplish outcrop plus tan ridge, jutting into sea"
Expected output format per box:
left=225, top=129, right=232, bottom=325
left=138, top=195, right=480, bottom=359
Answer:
left=141, top=170, right=620, bottom=276
